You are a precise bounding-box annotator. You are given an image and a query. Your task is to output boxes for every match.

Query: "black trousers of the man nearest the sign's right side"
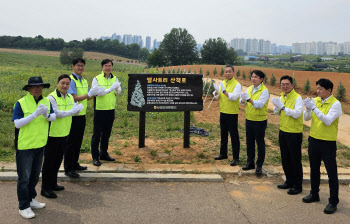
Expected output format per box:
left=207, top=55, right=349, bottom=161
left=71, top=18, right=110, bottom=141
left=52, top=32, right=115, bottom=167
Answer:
left=220, top=113, right=240, bottom=159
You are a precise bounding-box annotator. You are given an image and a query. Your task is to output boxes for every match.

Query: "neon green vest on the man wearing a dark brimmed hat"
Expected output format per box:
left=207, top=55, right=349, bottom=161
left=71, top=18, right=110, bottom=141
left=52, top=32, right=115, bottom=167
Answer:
left=18, top=92, right=50, bottom=150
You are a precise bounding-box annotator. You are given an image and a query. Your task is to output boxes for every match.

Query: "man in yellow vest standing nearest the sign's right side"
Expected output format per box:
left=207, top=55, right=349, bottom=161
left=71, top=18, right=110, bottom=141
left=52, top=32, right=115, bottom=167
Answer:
left=213, top=65, right=242, bottom=166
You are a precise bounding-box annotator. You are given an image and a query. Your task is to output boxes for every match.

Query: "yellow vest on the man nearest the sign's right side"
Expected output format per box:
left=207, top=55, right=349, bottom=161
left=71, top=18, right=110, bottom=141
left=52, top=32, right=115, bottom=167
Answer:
left=219, top=78, right=239, bottom=114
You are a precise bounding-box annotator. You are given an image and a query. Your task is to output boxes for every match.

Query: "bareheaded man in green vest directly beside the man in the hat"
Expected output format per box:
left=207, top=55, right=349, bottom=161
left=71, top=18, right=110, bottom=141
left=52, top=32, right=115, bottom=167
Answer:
left=41, top=74, right=84, bottom=198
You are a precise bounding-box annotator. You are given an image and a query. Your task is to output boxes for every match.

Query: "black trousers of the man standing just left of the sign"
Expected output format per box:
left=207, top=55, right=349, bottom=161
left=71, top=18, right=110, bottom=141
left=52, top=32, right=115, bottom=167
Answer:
left=91, top=110, right=115, bottom=159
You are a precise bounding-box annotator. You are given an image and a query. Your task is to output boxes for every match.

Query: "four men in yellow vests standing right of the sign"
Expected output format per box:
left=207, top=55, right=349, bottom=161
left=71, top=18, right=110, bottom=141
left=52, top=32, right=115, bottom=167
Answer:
left=213, top=65, right=342, bottom=214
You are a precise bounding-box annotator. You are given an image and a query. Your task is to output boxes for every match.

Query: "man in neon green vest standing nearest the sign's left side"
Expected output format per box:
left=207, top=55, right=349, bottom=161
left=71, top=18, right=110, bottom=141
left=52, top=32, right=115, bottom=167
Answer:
left=91, top=59, right=121, bottom=166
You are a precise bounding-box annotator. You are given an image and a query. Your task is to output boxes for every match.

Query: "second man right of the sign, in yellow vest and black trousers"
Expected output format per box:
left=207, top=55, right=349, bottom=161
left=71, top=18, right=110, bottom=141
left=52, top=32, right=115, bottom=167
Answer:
left=240, top=70, right=270, bottom=175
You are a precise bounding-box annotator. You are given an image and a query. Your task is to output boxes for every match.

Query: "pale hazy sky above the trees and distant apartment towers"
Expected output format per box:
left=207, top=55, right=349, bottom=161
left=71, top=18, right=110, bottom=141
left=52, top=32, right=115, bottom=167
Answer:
left=0, top=0, right=350, bottom=46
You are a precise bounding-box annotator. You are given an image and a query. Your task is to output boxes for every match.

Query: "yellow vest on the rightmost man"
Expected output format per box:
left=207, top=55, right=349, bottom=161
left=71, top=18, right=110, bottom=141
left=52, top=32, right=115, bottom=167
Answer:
left=310, top=95, right=339, bottom=141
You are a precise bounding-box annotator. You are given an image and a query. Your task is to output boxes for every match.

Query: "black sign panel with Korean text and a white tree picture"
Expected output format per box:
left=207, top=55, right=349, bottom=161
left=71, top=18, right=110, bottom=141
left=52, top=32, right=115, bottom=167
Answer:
left=128, top=74, right=203, bottom=112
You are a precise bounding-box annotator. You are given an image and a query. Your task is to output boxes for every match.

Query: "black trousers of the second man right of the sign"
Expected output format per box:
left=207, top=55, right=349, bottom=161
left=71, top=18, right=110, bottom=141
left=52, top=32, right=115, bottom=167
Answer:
left=245, top=120, right=267, bottom=167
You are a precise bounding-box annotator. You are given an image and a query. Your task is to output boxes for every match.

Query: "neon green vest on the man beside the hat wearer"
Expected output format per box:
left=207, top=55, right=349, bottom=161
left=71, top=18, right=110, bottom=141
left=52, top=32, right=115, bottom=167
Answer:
left=49, top=89, right=74, bottom=137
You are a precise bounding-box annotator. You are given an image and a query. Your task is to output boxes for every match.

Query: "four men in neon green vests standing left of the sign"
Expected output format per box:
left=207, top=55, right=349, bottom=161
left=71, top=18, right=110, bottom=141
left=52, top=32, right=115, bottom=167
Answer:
left=12, top=58, right=121, bottom=218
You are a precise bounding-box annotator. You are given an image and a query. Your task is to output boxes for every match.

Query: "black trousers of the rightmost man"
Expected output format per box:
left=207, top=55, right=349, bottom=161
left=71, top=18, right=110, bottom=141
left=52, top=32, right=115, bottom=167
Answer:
left=308, top=136, right=339, bottom=205
